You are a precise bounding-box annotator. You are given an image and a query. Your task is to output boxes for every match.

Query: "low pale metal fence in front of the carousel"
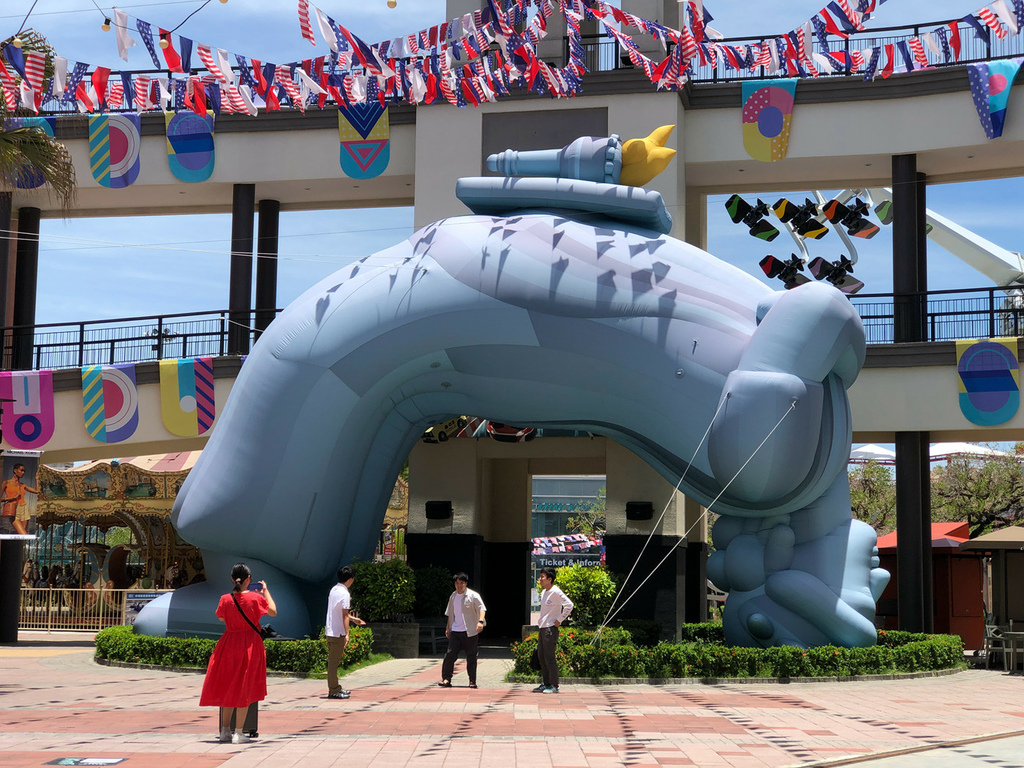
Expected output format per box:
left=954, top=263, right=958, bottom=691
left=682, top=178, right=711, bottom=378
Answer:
left=17, top=587, right=173, bottom=632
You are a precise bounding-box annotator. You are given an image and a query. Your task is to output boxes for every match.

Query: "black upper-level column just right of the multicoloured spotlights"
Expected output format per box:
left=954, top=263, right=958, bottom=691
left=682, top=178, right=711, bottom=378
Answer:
left=893, top=155, right=928, bottom=344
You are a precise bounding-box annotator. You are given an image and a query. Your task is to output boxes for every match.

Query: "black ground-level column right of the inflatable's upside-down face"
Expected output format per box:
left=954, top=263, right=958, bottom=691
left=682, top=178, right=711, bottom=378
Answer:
left=896, top=432, right=935, bottom=632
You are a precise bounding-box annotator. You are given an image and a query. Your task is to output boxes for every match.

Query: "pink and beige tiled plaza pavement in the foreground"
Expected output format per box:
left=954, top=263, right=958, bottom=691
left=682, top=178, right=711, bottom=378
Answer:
left=0, top=633, right=1024, bottom=768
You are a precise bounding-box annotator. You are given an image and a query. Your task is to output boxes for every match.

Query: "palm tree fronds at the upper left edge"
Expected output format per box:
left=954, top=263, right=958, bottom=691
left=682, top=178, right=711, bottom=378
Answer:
left=0, top=30, right=78, bottom=213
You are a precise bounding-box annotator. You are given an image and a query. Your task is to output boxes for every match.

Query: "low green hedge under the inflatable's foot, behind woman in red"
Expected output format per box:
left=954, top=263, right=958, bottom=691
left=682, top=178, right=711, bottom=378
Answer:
left=96, top=627, right=374, bottom=675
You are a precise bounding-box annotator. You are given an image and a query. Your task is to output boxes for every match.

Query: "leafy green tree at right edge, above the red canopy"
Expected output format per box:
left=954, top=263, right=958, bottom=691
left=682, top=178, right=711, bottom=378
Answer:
left=932, top=443, right=1024, bottom=539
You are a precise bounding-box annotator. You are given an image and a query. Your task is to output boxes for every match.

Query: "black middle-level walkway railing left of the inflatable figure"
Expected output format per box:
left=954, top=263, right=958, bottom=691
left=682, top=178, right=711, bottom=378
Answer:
left=0, top=309, right=281, bottom=370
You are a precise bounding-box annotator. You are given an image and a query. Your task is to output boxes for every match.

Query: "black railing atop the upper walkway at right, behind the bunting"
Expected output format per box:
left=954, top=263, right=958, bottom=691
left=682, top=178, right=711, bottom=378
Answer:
left=563, top=19, right=1024, bottom=83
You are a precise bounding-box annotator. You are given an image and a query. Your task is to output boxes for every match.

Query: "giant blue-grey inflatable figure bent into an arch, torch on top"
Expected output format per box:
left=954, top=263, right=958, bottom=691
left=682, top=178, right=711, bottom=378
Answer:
left=135, top=127, right=888, bottom=646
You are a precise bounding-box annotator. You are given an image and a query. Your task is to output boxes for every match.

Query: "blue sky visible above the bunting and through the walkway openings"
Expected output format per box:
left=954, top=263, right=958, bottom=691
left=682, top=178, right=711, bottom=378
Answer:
left=0, top=0, right=1024, bottom=323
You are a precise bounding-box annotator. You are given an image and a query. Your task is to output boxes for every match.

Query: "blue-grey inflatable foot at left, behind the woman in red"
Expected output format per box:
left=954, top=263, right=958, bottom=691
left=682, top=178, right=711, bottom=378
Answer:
left=135, top=552, right=311, bottom=638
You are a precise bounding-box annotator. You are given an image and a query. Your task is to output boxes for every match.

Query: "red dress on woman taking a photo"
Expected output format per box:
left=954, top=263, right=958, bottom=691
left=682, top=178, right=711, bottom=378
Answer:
left=199, top=591, right=269, bottom=708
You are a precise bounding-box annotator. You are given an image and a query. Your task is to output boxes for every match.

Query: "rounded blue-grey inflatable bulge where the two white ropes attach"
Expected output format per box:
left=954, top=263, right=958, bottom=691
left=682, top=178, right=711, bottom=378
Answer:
left=708, top=371, right=823, bottom=503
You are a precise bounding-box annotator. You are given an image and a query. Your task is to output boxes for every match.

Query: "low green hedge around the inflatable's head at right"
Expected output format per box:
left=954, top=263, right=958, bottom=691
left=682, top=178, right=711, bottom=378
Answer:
left=512, top=625, right=964, bottom=679
